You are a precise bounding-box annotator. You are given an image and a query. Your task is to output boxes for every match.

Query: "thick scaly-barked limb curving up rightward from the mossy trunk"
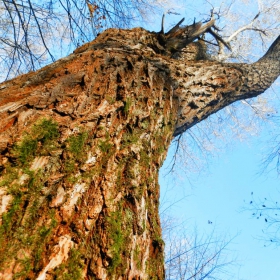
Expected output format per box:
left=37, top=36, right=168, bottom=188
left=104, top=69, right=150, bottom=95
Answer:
left=171, top=36, right=280, bottom=137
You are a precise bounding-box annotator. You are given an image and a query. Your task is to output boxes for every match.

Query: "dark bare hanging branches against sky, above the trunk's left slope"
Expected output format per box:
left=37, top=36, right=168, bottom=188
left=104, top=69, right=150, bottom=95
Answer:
left=0, top=0, right=164, bottom=79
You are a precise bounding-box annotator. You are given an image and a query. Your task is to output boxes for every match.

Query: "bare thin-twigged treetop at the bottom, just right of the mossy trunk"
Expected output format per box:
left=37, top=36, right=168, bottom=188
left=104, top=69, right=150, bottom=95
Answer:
left=161, top=211, right=237, bottom=280
